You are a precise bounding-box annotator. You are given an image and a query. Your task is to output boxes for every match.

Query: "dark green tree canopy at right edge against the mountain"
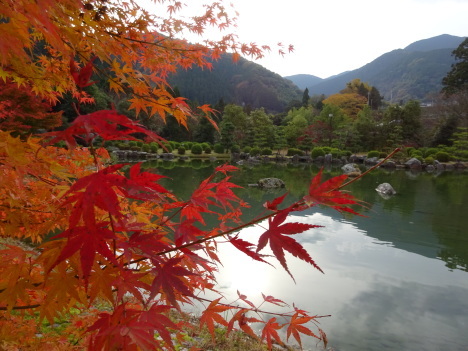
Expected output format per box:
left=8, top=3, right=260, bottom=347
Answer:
left=442, top=38, right=468, bottom=95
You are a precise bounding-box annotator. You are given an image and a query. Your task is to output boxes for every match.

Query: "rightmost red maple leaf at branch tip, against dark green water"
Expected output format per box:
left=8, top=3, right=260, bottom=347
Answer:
left=304, top=168, right=359, bottom=215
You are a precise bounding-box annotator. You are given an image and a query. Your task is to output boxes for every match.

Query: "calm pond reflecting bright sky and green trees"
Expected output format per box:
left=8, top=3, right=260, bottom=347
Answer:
left=147, top=162, right=468, bottom=351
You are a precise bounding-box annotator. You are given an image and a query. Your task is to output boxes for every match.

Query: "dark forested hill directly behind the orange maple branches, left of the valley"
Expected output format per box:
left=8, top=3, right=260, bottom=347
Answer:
left=168, top=55, right=303, bottom=113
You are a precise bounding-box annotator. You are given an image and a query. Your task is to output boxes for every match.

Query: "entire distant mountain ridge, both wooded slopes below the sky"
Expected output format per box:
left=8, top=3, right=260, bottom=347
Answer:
left=168, top=34, right=465, bottom=113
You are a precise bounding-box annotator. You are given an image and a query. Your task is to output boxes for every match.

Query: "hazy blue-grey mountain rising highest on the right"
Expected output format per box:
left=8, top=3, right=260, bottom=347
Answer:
left=287, top=34, right=465, bottom=102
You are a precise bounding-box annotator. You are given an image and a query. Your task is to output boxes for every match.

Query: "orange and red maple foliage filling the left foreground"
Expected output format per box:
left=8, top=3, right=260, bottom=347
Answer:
left=0, top=0, right=356, bottom=350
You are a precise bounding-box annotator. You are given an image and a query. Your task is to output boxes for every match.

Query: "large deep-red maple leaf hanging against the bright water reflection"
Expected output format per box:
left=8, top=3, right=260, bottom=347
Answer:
left=257, top=209, right=323, bottom=280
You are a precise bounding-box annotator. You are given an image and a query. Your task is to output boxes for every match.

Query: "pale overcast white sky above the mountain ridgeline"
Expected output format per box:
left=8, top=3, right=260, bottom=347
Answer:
left=233, top=0, right=468, bottom=78
